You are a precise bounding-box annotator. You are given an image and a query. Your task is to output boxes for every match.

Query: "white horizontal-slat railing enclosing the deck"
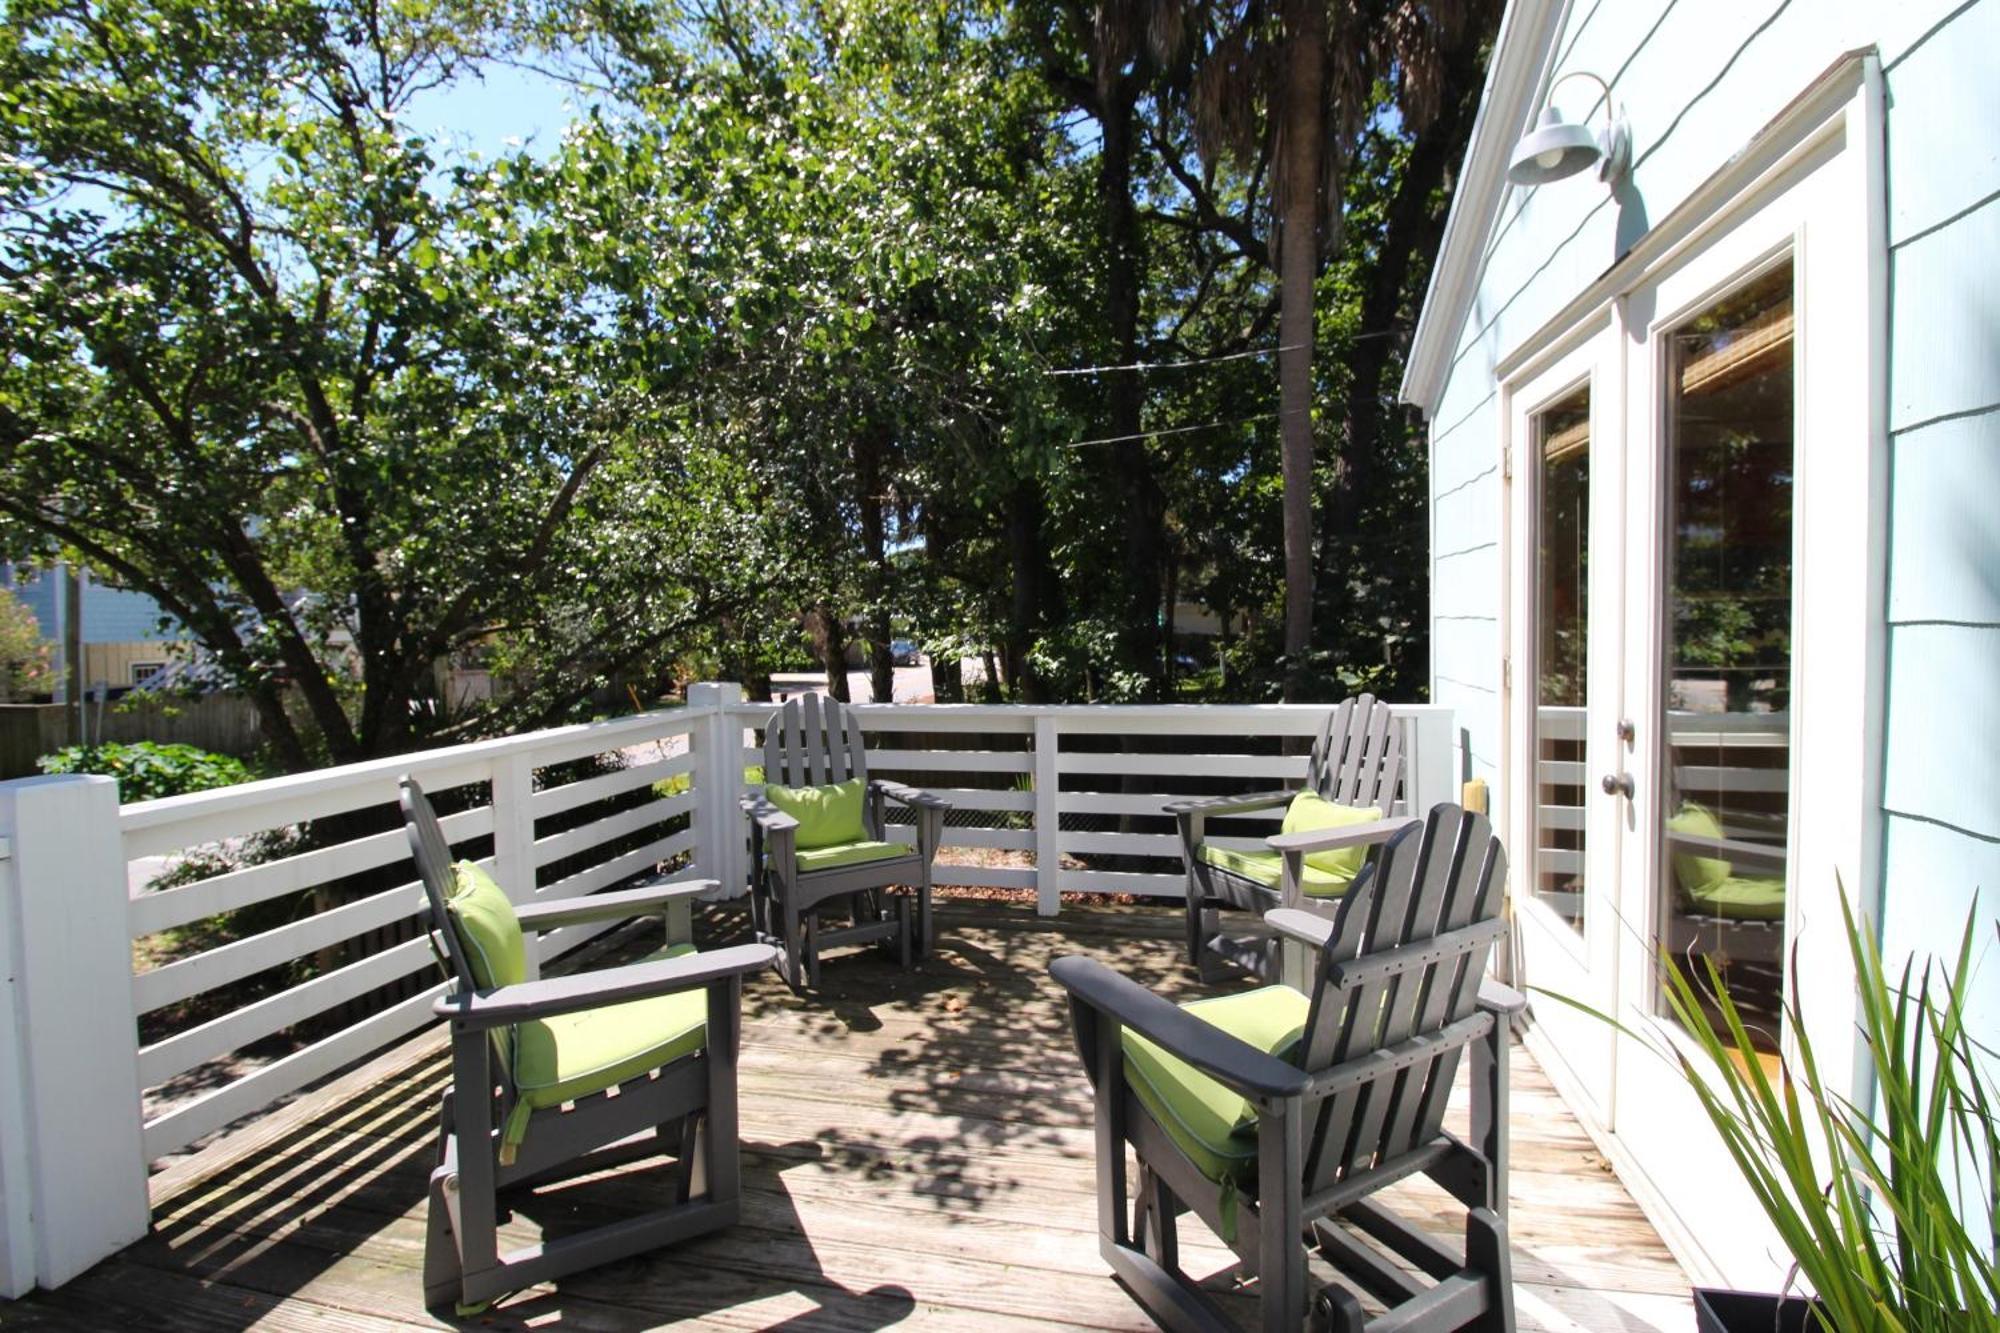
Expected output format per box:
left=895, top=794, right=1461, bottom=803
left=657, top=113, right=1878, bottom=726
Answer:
left=0, top=685, right=1460, bottom=1293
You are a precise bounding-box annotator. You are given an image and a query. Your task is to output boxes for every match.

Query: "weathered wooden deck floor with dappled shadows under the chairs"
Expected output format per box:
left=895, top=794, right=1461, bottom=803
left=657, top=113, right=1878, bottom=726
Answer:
left=0, top=903, right=1692, bottom=1333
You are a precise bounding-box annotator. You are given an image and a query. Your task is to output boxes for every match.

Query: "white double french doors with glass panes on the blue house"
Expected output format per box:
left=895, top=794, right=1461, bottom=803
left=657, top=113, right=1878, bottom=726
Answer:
left=1502, top=65, right=1886, bottom=1285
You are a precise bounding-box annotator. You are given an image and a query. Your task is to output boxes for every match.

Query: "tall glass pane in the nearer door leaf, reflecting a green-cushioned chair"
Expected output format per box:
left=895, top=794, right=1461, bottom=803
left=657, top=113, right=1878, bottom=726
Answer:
left=1654, top=264, right=1794, bottom=1055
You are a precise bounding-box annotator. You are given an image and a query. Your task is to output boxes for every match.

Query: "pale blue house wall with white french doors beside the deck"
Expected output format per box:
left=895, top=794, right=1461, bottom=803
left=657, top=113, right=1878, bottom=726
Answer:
left=1404, top=0, right=2000, bottom=1287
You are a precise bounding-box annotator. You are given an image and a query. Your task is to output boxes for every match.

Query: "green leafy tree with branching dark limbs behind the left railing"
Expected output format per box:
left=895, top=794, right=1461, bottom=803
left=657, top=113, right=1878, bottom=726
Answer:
left=0, top=0, right=772, bottom=767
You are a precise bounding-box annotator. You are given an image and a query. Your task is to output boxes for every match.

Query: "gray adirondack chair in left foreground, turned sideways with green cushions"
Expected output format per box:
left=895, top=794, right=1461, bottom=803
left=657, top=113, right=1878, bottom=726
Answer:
left=402, top=777, right=772, bottom=1313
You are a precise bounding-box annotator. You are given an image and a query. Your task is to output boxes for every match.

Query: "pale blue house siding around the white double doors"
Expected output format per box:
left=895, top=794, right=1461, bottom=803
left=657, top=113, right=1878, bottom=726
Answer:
left=1430, top=0, right=2000, bottom=1033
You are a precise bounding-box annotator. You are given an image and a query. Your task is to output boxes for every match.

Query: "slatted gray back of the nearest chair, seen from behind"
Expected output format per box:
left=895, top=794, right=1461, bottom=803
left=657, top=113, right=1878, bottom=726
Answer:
left=1302, top=805, right=1506, bottom=1193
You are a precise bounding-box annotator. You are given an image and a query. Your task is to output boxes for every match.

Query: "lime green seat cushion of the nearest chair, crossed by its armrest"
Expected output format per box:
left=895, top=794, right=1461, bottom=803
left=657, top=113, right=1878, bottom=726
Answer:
left=1124, top=987, right=1310, bottom=1185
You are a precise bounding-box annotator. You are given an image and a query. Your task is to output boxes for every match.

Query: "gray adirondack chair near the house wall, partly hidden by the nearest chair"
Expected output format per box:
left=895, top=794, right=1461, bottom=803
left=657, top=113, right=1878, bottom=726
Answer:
left=1164, top=695, right=1410, bottom=977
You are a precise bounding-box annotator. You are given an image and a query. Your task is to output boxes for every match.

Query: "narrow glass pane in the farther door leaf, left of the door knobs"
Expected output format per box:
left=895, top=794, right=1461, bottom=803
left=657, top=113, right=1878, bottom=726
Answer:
left=1530, top=384, right=1590, bottom=935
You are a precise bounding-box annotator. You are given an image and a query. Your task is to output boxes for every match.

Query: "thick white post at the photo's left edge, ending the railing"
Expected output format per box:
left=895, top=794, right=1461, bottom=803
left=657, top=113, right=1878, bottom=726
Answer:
left=0, top=777, right=150, bottom=1297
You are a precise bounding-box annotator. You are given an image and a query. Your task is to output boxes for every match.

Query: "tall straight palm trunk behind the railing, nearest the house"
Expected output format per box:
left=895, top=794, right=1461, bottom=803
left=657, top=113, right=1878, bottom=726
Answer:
left=1274, top=0, right=1326, bottom=701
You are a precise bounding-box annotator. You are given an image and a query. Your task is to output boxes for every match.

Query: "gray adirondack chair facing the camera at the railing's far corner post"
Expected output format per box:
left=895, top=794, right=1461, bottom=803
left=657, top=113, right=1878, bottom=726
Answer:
left=742, top=695, right=952, bottom=987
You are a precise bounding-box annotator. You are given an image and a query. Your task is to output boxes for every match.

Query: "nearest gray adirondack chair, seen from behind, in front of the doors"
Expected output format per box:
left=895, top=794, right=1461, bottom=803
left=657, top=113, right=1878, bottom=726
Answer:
left=1050, top=805, right=1522, bottom=1333
